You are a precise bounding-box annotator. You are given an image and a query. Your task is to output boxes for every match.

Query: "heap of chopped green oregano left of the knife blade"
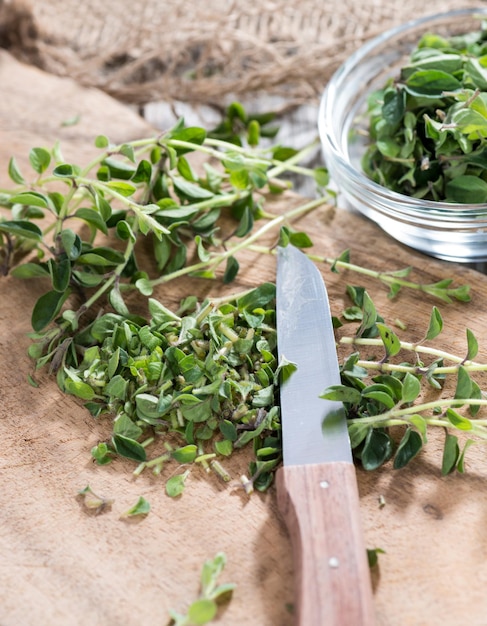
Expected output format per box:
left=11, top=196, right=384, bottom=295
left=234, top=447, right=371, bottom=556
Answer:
left=72, top=283, right=281, bottom=495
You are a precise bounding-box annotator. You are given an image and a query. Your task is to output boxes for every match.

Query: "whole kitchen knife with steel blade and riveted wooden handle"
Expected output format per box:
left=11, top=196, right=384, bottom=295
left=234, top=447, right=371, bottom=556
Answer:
left=276, top=245, right=375, bottom=626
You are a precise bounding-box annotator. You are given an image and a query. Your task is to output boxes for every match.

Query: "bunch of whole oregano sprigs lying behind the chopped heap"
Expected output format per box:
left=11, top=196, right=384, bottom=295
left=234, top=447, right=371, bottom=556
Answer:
left=0, top=111, right=327, bottom=332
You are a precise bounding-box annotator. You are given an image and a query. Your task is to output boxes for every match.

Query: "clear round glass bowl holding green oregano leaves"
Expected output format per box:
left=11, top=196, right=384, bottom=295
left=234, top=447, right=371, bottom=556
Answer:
left=318, top=8, right=487, bottom=263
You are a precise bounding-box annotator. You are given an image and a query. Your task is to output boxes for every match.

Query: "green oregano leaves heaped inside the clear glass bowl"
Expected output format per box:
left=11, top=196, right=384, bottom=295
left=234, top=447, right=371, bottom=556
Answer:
left=362, top=21, right=487, bottom=204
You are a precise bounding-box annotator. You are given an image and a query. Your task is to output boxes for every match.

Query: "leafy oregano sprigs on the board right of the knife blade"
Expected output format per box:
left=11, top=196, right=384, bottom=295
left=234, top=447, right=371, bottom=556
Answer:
left=322, top=290, right=487, bottom=474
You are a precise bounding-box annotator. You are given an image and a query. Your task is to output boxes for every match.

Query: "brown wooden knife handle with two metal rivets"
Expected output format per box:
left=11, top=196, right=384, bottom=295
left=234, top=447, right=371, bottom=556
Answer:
left=276, top=462, right=375, bottom=626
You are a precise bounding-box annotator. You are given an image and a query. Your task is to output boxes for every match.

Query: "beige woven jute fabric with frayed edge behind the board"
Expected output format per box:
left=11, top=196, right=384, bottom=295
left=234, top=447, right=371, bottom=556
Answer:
left=0, top=0, right=485, bottom=105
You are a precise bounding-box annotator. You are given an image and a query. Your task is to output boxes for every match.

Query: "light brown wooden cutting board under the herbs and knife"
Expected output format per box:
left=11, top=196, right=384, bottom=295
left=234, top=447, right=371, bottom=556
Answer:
left=0, top=53, right=487, bottom=626
